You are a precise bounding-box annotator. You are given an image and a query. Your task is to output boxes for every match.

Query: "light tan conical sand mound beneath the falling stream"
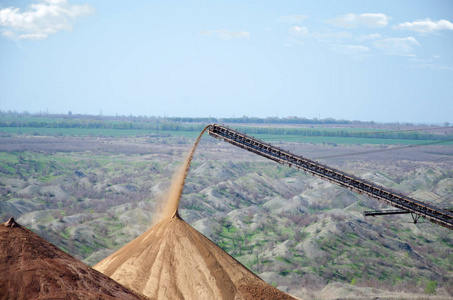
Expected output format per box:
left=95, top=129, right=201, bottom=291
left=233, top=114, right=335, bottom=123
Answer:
left=94, top=214, right=294, bottom=300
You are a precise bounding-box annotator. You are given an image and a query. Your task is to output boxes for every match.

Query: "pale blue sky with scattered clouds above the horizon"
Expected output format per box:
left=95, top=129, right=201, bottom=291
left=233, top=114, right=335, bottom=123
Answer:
left=0, top=0, right=453, bottom=124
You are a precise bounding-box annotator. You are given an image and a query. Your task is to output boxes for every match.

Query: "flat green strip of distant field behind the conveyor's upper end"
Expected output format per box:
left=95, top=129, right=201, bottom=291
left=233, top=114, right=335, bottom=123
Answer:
left=0, top=127, right=453, bottom=145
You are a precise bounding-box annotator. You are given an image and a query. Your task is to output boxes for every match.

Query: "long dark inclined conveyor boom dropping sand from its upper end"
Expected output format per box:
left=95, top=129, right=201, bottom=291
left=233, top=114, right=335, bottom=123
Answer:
left=208, top=124, right=453, bottom=230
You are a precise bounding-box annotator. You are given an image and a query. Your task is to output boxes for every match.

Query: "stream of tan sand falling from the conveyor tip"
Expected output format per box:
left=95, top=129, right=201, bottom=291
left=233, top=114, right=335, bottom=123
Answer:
left=157, top=125, right=210, bottom=222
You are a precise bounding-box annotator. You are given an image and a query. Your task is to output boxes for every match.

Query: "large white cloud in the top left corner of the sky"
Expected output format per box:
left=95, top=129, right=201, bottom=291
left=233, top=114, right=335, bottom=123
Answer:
left=0, top=0, right=94, bottom=40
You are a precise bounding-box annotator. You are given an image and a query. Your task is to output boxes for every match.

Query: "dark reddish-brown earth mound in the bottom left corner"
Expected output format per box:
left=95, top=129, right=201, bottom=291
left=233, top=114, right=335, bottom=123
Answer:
left=0, top=220, right=144, bottom=300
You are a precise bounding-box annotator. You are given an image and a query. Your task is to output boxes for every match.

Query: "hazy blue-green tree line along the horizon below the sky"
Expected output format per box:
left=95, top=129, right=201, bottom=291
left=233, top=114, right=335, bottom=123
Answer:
left=0, top=110, right=453, bottom=141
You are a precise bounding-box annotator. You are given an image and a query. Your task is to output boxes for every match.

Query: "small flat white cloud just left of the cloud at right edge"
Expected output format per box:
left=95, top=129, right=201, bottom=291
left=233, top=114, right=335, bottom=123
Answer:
left=327, top=13, right=390, bottom=28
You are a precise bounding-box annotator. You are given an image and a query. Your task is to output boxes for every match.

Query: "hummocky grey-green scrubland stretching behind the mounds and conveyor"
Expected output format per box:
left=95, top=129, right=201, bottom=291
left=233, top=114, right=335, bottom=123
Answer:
left=0, top=113, right=453, bottom=294
